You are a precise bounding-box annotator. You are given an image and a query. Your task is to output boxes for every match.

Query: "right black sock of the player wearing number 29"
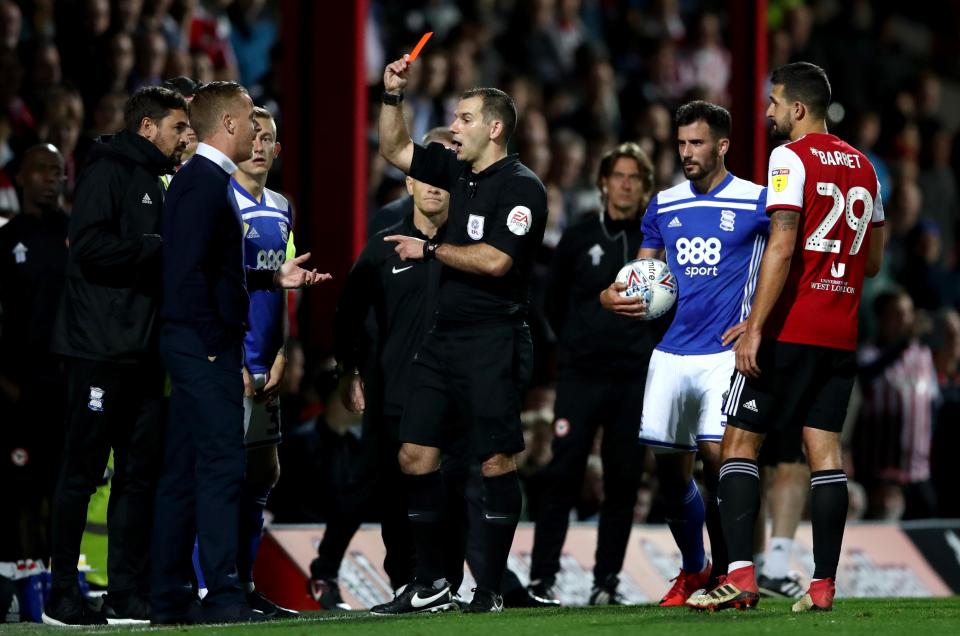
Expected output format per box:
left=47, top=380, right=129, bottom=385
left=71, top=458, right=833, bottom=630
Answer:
left=810, top=468, right=847, bottom=579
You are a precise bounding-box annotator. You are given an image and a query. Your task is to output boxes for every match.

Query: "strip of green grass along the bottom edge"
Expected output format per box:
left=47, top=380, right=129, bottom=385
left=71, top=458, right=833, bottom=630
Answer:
left=7, top=597, right=960, bottom=636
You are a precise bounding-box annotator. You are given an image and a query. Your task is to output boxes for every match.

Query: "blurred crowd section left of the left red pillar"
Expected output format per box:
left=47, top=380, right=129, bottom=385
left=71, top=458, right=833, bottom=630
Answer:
left=0, top=0, right=278, bottom=217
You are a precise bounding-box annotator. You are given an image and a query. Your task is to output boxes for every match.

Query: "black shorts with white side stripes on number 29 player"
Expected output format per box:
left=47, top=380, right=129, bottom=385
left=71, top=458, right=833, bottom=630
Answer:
left=723, top=341, right=857, bottom=436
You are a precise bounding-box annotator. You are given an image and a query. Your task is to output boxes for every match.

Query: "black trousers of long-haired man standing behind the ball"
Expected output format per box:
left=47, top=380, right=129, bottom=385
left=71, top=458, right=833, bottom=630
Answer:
left=530, top=373, right=646, bottom=583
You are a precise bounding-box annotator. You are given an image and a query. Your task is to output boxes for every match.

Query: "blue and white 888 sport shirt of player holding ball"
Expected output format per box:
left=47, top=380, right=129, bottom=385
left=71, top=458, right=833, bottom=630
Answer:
left=641, top=174, right=770, bottom=355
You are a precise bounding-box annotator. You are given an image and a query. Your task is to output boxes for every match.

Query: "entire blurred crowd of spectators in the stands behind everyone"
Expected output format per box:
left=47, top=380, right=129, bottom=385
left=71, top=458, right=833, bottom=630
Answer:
left=0, top=0, right=960, bottom=572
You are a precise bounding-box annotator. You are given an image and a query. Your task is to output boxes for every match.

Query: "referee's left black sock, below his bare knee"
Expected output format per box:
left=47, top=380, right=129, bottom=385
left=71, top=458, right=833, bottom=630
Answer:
left=404, top=470, right=446, bottom=585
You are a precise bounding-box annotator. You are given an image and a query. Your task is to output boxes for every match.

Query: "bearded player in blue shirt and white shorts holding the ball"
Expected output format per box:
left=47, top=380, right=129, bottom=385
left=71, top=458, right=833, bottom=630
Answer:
left=601, top=101, right=768, bottom=606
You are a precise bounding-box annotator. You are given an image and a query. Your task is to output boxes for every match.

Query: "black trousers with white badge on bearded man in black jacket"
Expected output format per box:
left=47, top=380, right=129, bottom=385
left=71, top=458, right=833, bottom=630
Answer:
left=52, top=359, right=164, bottom=595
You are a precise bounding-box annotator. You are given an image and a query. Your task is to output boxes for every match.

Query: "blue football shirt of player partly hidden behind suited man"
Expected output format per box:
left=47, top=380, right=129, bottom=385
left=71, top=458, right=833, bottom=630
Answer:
left=230, top=177, right=295, bottom=373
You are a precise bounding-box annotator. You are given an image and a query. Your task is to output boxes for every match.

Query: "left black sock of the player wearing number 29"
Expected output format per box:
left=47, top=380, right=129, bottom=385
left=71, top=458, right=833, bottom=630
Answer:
left=717, top=457, right=760, bottom=563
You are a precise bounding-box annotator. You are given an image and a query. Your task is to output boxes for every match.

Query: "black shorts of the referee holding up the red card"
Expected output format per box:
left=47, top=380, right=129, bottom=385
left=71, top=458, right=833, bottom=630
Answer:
left=400, top=322, right=533, bottom=459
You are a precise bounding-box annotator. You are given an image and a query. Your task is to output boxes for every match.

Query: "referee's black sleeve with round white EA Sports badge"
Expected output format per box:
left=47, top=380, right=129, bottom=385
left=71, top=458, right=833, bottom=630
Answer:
left=483, top=177, right=547, bottom=259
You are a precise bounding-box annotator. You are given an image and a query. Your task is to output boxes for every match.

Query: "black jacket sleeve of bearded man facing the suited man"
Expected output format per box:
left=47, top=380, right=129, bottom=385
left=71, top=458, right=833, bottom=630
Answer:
left=69, top=161, right=162, bottom=269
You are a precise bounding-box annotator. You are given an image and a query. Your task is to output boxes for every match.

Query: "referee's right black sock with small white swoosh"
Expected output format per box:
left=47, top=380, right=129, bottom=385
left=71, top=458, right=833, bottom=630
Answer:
left=477, top=471, right=523, bottom=594
